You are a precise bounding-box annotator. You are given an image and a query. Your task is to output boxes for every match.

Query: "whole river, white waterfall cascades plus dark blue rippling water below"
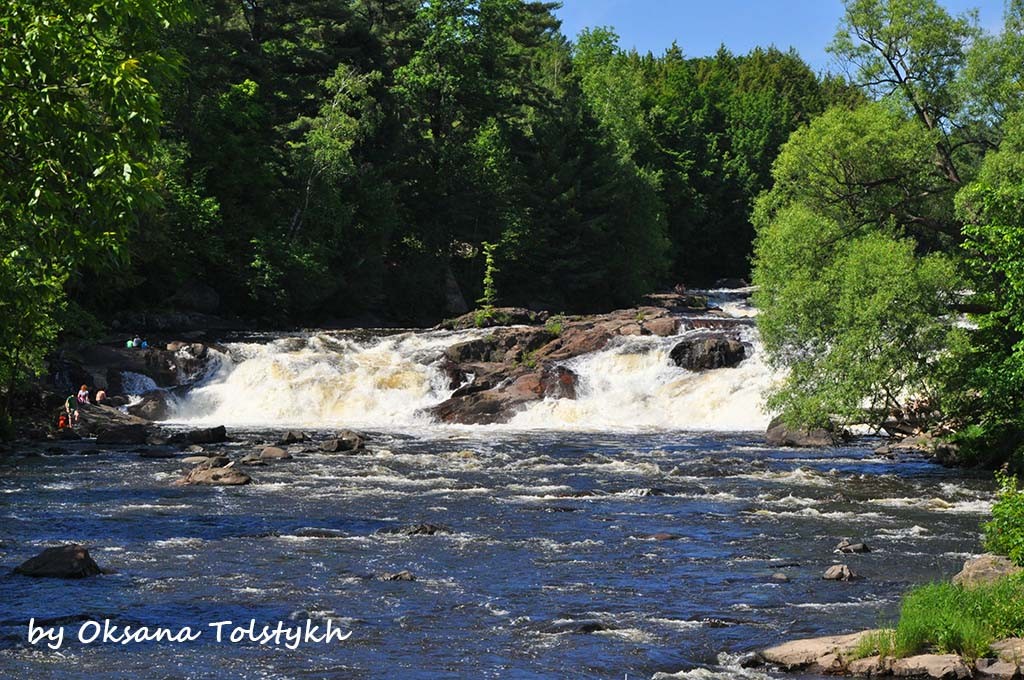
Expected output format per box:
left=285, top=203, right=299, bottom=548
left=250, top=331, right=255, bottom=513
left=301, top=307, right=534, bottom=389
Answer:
left=0, top=292, right=992, bottom=678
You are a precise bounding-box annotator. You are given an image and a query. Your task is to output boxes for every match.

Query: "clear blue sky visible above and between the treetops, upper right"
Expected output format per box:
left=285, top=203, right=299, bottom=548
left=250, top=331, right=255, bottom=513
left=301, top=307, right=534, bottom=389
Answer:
left=557, top=0, right=1004, bottom=72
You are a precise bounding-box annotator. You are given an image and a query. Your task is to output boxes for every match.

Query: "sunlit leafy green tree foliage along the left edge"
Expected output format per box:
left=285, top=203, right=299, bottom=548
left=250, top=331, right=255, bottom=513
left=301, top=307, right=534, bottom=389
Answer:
left=0, top=0, right=185, bottom=425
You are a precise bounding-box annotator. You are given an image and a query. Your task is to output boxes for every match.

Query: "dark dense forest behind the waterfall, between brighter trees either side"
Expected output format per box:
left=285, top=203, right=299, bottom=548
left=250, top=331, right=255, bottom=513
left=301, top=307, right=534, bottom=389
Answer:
left=74, top=0, right=839, bottom=324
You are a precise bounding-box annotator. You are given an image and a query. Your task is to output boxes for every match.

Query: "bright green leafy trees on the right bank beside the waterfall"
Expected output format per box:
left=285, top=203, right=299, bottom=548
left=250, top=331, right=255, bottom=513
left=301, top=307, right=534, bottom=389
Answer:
left=754, top=0, right=1024, bottom=463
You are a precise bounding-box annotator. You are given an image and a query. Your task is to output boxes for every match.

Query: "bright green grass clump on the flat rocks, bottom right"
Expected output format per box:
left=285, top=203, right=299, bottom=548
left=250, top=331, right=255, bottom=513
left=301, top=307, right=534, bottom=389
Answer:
left=854, top=575, right=1024, bottom=661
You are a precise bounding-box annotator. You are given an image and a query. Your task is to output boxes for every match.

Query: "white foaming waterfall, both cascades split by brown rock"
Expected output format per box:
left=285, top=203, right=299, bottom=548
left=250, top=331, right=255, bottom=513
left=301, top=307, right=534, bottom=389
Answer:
left=174, top=292, right=774, bottom=431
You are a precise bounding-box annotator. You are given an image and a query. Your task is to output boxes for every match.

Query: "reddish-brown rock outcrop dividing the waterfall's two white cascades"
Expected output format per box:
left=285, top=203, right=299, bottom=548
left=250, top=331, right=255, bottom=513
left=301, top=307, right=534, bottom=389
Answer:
left=429, top=303, right=744, bottom=425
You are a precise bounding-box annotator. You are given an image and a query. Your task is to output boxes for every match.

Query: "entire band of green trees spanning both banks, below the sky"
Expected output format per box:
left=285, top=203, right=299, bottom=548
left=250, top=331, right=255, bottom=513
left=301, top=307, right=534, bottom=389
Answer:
left=6, top=0, right=1024, bottom=456
